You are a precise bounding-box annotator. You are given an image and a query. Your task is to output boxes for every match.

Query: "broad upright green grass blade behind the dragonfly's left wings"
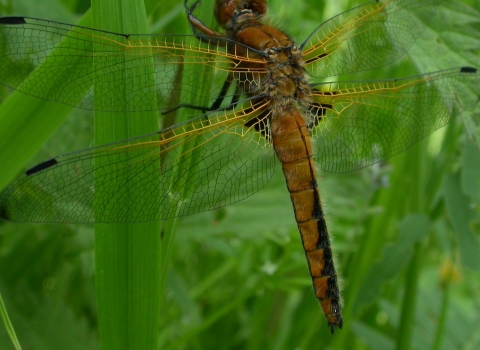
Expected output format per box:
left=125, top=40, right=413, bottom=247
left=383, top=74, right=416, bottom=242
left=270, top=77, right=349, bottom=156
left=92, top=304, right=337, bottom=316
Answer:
left=92, top=0, right=160, bottom=350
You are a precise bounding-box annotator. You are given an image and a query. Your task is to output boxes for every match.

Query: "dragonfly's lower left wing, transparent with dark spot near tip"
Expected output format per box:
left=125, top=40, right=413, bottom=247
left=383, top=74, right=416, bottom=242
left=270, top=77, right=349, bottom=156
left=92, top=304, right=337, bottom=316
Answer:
left=0, top=103, right=275, bottom=223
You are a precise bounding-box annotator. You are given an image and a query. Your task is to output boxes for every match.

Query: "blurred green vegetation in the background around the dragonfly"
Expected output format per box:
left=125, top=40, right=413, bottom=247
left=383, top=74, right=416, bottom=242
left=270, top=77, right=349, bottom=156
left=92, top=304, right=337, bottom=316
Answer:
left=0, top=0, right=480, bottom=350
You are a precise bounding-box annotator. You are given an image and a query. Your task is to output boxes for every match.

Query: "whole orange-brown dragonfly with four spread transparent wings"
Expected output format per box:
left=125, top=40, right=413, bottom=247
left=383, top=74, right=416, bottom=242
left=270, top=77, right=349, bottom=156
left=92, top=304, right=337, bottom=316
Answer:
left=0, top=0, right=480, bottom=333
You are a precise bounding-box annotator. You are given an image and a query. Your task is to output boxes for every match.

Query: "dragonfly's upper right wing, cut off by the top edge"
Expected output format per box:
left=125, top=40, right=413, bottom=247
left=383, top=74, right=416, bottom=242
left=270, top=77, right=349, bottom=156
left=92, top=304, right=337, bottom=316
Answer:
left=302, top=0, right=443, bottom=77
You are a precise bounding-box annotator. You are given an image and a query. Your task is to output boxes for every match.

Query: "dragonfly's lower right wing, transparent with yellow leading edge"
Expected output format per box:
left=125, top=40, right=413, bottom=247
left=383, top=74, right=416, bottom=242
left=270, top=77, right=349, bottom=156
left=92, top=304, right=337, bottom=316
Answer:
left=311, top=68, right=480, bottom=173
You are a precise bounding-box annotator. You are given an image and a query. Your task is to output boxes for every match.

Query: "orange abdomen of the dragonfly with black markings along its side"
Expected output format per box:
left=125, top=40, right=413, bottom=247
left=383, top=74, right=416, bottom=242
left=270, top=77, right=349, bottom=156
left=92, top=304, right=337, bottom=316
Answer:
left=270, top=105, right=342, bottom=333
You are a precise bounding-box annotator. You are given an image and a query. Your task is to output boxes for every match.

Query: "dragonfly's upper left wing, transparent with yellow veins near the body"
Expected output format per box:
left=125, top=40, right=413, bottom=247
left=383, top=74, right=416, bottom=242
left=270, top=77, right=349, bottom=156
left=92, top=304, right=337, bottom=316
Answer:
left=0, top=17, right=265, bottom=112
